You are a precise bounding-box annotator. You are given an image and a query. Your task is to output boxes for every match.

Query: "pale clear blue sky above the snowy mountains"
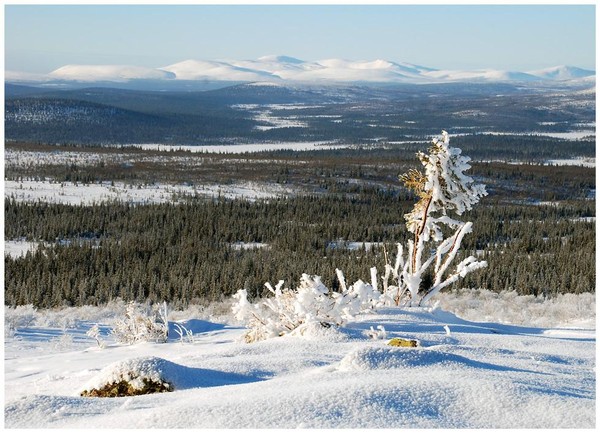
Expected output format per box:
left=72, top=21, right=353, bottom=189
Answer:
left=4, top=4, right=596, bottom=73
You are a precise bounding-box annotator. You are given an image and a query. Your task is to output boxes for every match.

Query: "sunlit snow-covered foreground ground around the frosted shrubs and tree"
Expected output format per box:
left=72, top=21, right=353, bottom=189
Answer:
left=5, top=291, right=596, bottom=429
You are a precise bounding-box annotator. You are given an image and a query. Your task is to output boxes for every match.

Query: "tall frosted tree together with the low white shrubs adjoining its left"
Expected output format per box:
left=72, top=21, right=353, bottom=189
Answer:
left=233, top=131, right=487, bottom=342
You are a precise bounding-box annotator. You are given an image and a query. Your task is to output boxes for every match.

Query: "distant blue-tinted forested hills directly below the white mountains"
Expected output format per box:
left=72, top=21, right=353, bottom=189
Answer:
left=5, top=83, right=595, bottom=150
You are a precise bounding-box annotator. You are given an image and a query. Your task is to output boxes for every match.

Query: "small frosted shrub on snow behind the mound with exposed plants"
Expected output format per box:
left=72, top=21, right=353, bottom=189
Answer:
left=111, top=302, right=169, bottom=344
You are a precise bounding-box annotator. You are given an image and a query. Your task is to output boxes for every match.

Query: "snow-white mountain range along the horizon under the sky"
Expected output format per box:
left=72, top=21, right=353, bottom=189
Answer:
left=6, top=56, right=595, bottom=84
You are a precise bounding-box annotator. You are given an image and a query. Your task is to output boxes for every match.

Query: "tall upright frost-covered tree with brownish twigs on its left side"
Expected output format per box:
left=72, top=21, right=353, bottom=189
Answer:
left=384, top=131, right=487, bottom=306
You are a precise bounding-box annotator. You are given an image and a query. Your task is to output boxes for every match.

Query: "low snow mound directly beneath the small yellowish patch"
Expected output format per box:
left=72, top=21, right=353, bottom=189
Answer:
left=339, top=347, right=472, bottom=371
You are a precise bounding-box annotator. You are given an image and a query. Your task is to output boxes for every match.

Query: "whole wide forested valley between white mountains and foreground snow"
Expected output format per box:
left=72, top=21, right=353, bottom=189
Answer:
left=5, top=82, right=596, bottom=308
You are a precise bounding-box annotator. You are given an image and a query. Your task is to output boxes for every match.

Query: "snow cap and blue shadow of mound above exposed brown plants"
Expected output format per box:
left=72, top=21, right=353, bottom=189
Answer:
left=80, top=356, right=258, bottom=393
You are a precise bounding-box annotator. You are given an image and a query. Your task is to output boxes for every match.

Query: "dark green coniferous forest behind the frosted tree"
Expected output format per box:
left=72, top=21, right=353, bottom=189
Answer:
left=5, top=141, right=595, bottom=308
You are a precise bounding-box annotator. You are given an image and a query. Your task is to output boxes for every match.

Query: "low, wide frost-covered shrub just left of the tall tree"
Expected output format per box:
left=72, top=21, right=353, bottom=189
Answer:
left=232, top=270, right=381, bottom=342
